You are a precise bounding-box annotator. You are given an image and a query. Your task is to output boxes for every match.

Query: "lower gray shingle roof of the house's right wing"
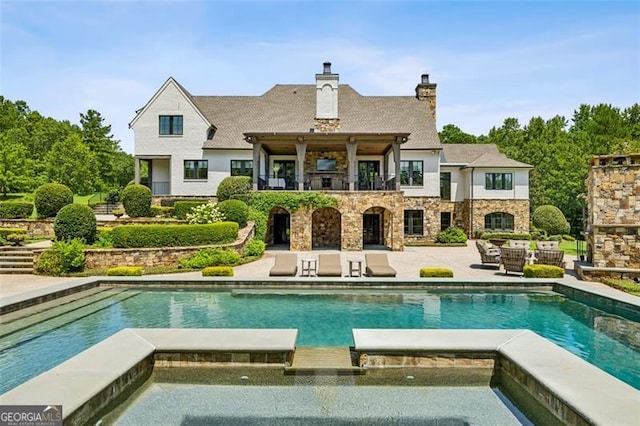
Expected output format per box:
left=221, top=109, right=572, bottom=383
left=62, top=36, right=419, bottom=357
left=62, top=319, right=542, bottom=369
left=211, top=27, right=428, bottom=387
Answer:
left=442, top=143, right=533, bottom=169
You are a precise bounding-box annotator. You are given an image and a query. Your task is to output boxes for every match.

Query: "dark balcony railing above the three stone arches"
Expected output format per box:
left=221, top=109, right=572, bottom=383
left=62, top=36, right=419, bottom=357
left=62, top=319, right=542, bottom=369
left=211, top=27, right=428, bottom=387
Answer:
left=258, top=173, right=396, bottom=191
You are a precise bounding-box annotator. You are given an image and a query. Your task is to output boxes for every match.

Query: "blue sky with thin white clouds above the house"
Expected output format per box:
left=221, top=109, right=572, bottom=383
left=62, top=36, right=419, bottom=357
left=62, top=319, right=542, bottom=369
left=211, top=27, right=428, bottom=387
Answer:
left=0, top=0, right=640, bottom=152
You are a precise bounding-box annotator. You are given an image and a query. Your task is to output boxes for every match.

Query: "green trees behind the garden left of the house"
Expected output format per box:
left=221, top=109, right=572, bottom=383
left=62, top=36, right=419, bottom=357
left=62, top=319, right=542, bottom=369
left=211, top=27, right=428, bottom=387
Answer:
left=0, top=96, right=134, bottom=197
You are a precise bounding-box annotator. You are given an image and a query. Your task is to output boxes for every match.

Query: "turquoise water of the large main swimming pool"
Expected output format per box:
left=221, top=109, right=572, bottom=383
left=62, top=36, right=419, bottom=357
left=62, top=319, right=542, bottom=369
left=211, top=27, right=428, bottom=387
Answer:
left=0, top=289, right=640, bottom=393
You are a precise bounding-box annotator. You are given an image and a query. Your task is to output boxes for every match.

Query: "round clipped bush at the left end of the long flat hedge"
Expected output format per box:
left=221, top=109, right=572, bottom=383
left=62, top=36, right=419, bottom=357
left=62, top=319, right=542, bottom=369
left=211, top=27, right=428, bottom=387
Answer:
left=53, top=204, right=96, bottom=244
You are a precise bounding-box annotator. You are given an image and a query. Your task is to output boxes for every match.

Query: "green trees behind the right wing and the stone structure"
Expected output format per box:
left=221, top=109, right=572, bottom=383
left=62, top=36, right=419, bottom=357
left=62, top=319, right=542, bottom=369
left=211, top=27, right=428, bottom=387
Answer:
left=439, top=103, right=640, bottom=233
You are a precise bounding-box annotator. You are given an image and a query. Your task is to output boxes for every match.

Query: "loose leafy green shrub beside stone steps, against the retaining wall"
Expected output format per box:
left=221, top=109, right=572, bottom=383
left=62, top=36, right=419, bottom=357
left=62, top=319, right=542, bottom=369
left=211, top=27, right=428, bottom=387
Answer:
left=35, top=240, right=85, bottom=276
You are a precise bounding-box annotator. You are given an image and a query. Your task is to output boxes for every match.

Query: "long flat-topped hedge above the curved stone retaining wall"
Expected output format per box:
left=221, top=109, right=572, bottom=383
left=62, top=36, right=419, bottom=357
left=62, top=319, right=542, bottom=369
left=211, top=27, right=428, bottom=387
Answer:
left=111, top=222, right=239, bottom=248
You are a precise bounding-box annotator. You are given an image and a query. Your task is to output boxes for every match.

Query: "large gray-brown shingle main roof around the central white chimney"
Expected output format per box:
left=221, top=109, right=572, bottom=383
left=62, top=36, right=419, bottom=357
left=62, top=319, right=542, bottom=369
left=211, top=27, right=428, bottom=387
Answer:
left=192, top=84, right=441, bottom=149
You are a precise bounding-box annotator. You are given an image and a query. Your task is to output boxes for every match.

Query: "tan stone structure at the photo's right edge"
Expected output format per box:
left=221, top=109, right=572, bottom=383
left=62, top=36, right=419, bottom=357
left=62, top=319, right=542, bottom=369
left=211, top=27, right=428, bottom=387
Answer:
left=587, top=154, right=640, bottom=269
